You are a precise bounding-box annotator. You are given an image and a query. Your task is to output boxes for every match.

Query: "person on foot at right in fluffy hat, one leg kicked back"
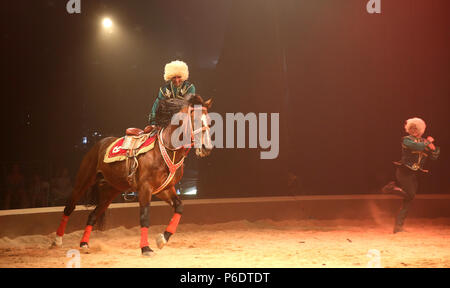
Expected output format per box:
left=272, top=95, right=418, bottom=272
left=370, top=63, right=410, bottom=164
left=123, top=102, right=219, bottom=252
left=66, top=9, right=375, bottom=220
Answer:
left=382, top=118, right=440, bottom=233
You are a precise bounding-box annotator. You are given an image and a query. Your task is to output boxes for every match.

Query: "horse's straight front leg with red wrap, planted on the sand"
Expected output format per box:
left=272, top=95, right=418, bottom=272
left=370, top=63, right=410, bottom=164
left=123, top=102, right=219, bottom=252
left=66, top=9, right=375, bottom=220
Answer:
left=139, top=185, right=154, bottom=256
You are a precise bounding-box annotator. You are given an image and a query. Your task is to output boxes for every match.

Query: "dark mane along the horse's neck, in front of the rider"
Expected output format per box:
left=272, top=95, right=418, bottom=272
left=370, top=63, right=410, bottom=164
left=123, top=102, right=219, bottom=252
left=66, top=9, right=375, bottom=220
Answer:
left=155, top=94, right=203, bottom=128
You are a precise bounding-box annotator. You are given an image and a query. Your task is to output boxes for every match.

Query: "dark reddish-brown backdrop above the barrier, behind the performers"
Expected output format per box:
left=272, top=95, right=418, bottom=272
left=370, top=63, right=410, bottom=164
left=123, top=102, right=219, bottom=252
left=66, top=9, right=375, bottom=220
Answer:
left=1, top=0, right=450, bottom=202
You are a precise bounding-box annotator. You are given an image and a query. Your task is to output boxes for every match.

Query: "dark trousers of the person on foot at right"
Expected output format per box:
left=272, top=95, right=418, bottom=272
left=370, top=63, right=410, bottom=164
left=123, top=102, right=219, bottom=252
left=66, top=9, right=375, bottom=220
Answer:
left=395, top=166, right=418, bottom=227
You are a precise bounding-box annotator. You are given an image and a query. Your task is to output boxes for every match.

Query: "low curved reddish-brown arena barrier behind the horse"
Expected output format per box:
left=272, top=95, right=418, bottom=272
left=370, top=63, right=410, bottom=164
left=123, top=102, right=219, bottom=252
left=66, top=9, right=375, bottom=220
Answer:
left=0, top=194, right=450, bottom=238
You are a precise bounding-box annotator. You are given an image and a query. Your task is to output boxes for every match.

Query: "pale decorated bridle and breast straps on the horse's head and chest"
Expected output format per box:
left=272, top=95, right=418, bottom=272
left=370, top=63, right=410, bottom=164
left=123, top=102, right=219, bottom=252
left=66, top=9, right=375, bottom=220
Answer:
left=152, top=106, right=209, bottom=195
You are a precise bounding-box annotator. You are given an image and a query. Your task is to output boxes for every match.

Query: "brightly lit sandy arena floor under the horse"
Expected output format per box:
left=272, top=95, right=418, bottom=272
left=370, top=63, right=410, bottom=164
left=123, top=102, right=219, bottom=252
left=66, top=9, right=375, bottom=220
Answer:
left=0, top=219, right=450, bottom=268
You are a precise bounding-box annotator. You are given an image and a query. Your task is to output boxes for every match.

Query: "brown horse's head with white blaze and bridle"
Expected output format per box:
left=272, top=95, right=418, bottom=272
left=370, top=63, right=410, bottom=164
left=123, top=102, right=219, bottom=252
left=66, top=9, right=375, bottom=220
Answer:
left=184, top=94, right=213, bottom=157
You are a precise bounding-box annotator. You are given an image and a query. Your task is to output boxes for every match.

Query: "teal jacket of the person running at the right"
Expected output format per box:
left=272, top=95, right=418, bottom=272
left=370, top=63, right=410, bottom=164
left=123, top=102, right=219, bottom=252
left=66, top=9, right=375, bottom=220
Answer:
left=400, top=135, right=440, bottom=171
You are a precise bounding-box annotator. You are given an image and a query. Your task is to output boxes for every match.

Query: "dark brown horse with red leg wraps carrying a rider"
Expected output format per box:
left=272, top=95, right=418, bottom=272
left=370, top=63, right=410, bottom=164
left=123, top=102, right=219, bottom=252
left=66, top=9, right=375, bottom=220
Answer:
left=53, top=95, right=212, bottom=256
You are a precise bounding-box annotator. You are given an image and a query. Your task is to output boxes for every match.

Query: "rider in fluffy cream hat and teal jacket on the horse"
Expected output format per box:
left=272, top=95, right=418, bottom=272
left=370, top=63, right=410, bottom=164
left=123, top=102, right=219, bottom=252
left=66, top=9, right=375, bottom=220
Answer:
left=148, top=60, right=195, bottom=125
